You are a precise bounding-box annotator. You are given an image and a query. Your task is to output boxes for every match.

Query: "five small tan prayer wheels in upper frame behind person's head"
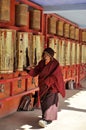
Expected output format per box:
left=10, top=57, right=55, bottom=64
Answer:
left=47, top=17, right=79, bottom=40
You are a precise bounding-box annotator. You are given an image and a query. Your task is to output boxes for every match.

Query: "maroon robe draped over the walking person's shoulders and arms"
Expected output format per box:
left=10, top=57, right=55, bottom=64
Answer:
left=29, top=58, right=65, bottom=97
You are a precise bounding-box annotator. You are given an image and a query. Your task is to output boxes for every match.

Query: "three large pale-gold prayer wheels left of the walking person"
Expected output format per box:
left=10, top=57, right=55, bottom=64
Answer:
left=0, top=29, right=44, bottom=73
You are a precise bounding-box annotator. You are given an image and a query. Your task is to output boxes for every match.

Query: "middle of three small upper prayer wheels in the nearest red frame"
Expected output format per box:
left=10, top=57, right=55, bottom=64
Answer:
left=15, top=4, right=29, bottom=26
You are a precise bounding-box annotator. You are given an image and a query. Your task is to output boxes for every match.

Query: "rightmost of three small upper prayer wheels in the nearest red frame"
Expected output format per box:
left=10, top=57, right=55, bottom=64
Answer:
left=30, top=10, right=41, bottom=30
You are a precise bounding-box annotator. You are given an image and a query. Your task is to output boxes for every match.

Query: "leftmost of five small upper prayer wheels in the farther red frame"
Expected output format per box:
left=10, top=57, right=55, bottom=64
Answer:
left=48, top=17, right=56, bottom=34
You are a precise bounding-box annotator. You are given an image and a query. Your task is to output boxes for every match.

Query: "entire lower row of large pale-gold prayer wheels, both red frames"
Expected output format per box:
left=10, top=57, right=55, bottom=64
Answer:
left=0, top=29, right=86, bottom=73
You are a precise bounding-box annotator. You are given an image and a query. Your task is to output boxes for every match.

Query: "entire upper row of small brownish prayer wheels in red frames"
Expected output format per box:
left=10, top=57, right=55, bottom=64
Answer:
left=0, top=0, right=86, bottom=42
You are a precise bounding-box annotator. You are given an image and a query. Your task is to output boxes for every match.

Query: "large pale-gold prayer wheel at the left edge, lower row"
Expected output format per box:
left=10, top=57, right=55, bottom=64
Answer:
left=0, top=29, right=16, bottom=73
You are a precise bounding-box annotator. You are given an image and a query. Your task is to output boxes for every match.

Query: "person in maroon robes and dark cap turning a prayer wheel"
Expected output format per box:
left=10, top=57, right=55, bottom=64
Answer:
left=26, top=47, right=65, bottom=127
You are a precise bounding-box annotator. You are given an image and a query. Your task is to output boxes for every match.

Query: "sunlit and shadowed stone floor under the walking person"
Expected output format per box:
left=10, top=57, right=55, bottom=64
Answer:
left=0, top=79, right=86, bottom=130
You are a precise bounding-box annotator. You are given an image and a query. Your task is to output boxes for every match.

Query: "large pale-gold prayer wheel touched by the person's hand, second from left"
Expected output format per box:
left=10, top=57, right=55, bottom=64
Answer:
left=16, top=32, right=28, bottom=71
